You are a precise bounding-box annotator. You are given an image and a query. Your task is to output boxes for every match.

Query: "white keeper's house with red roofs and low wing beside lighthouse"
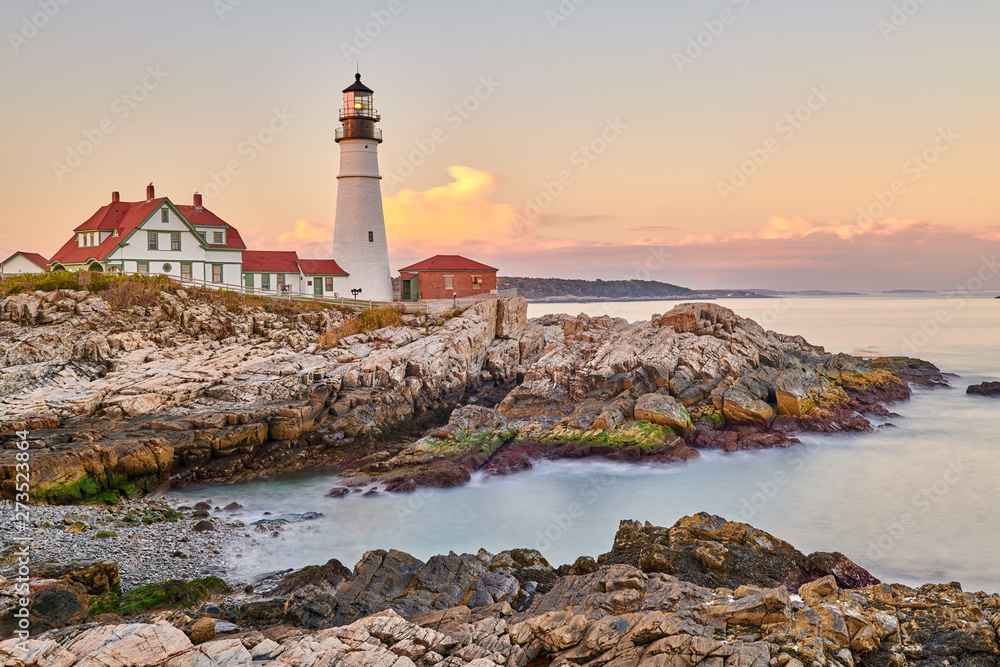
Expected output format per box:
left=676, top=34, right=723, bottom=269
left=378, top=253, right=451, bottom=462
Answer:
left=41, top=184, right=348, bottom=297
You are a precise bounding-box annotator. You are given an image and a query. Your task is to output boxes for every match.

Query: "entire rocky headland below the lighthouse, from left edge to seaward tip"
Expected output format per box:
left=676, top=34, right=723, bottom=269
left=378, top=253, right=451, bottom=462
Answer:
left=0, top=292, right=936, bottom=502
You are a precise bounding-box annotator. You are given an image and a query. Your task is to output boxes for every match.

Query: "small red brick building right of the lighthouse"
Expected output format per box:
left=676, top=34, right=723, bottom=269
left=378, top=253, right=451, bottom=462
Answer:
left=399, top=255, right=497, bottom=301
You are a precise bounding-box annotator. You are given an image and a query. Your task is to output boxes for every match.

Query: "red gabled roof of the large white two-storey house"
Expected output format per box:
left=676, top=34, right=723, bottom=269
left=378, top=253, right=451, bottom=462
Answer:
left=52, top=197, right=246, bottom=264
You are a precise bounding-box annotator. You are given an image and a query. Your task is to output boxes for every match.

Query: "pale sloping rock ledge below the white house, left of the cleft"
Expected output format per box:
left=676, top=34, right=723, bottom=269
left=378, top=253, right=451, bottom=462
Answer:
left=0, top=291, right=543, bottom=502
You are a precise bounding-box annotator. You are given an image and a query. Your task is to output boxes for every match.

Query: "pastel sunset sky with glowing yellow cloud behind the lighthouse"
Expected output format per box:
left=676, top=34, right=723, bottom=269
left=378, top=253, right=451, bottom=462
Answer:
left=0, top=0, right=1000, bottom=291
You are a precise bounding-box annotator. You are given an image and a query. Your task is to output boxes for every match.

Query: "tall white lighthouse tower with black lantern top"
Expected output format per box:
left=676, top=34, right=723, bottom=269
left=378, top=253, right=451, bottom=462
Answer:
left=333, top=74, right=393, bottom=301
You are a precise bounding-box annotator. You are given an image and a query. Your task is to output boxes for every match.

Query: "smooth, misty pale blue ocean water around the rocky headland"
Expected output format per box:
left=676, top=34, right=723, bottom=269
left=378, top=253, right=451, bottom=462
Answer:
left=170, top=296, right=1000, bottom=592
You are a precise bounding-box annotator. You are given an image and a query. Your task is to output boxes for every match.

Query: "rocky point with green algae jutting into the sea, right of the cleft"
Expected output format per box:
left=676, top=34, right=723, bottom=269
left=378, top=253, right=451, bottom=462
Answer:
left=344, top=304, right=943, bottom=492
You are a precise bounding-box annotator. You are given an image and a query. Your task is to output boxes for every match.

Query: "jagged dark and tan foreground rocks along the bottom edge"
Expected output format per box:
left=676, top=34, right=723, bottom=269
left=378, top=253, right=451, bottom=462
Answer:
left=0, top=514, right=1000, bottom=667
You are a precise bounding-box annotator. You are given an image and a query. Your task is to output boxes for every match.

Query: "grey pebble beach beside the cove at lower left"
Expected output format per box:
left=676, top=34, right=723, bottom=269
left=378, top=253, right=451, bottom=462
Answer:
left=0, top=499, right=260, bottom=590
